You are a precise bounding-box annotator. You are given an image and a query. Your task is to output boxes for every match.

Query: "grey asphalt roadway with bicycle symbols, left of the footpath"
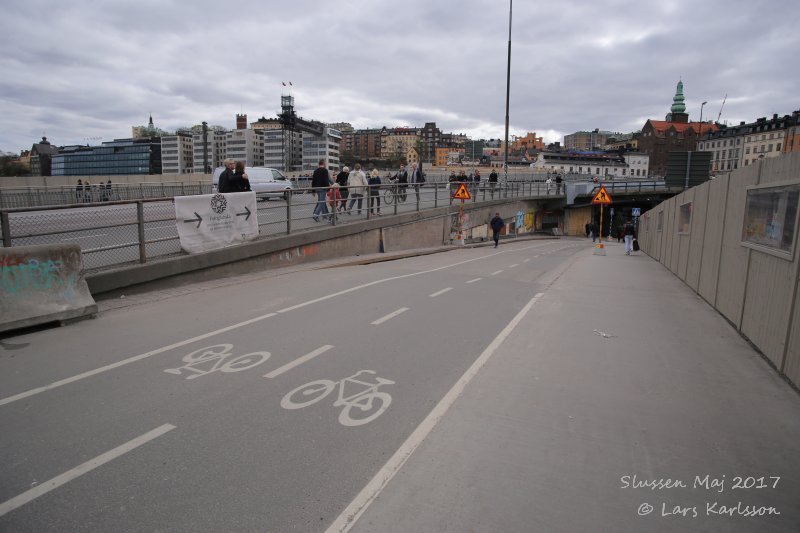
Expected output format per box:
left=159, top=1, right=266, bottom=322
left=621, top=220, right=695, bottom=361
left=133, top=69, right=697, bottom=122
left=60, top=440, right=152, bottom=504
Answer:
left=0, top=241, right=587, bottom=532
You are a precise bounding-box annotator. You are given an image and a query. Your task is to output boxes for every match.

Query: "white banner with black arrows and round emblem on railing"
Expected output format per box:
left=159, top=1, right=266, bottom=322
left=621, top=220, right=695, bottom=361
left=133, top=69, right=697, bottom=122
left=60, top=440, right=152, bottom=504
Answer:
left=175, top=192, right=258, bottom=253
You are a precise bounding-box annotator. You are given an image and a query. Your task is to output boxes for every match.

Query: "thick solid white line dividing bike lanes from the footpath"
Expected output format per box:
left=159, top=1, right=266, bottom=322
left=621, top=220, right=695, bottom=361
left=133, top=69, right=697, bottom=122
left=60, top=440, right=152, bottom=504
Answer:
left=326, top=293, right=542, bottom=533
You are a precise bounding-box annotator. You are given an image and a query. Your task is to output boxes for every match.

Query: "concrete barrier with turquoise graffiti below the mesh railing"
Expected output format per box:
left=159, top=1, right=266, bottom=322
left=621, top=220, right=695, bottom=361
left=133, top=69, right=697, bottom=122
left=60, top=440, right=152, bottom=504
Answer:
left=0, top=244, right=97, bottom=332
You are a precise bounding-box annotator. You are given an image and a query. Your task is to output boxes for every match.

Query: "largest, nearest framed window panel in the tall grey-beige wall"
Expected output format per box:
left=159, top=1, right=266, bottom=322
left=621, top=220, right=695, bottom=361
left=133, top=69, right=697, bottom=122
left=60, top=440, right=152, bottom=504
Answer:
left=742, top=184, right=800, bottom=259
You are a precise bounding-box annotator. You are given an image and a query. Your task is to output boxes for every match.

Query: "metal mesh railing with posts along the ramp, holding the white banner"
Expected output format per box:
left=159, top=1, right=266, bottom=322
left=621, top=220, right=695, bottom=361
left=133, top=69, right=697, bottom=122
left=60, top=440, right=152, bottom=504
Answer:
left=0, top=182, right=555, bottom=272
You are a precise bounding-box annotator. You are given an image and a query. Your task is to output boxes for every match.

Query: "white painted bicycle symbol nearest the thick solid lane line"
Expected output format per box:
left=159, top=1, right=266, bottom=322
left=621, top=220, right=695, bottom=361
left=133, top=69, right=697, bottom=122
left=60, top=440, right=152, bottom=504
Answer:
left=281, top=370, right=394, bottom=427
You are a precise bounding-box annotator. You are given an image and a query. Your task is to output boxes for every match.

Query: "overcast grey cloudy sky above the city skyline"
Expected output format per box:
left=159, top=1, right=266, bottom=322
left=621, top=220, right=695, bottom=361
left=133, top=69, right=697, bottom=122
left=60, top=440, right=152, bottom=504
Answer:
left=0, top=0, right=800, bottom=153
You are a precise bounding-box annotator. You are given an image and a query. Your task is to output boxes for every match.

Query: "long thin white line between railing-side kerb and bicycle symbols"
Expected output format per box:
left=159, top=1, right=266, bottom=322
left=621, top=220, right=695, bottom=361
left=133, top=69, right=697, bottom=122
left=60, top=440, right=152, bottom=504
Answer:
left=0, top=243, right=560, bottom=407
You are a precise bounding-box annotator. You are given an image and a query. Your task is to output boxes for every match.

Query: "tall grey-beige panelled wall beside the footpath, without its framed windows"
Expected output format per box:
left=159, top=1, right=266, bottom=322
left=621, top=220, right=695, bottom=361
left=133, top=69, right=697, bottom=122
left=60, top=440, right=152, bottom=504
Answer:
left=639, top=153, right=800, bottom=384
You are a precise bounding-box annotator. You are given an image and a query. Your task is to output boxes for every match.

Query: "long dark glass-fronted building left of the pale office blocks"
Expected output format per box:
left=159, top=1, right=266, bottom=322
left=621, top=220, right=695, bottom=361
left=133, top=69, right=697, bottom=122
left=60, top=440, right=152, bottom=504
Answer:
left=52, top=138, right=161, bottom=176
